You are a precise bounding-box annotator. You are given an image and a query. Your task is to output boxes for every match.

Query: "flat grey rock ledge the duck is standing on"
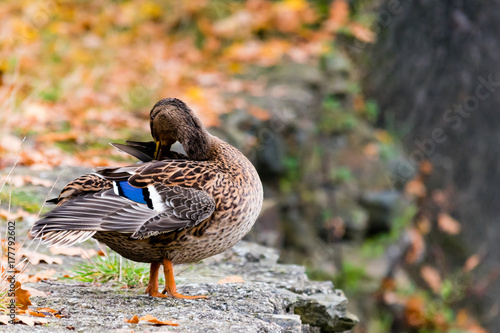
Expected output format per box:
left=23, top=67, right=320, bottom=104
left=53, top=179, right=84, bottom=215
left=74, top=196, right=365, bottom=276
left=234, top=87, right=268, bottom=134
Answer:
left=9, top=242, right=357, bottom=333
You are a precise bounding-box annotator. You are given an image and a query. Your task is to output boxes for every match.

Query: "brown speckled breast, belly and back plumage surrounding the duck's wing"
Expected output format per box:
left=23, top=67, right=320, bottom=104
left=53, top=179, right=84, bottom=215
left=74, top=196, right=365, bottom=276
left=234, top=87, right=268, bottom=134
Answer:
left=94, top=138, right=262, bottom=264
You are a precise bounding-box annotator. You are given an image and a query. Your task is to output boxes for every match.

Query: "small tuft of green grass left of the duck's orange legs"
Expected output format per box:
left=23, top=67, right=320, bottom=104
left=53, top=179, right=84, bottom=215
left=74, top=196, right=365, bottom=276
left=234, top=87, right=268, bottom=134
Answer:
left=69, top=252, right=161, bottom=287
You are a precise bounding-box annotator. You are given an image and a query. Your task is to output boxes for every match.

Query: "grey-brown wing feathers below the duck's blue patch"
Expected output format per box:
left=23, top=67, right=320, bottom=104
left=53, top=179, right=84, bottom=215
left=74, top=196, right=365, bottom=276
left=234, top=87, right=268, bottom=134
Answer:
left=32, top=184, right=215, bottom=240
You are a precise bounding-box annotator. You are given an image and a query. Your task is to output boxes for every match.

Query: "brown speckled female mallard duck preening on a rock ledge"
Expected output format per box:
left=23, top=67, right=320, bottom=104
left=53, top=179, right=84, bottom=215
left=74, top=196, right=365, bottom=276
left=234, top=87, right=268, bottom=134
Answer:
left=31, top=98, right=263, bottom=299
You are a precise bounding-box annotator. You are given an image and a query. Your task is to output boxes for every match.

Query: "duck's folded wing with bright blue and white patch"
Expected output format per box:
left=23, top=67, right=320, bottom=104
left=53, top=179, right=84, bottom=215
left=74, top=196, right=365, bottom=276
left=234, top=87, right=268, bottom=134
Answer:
left=31, top=161, right=215, bottom=245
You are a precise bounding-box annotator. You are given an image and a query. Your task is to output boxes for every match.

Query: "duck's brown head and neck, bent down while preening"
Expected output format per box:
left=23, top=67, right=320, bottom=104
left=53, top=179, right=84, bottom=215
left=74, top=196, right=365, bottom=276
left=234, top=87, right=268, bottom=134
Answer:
left=150, top=98, right=211, bottom=160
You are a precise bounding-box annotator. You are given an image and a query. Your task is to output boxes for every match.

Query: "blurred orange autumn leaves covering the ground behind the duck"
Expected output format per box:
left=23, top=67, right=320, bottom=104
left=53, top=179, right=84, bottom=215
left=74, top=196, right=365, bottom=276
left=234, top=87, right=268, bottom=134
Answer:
left=0, top=0, right=365, bottom=167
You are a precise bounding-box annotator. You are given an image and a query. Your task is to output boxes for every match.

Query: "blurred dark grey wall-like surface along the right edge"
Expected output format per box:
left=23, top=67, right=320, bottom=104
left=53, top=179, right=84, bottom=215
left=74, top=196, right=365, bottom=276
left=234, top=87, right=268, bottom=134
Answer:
left=364, top=0, right=500, bottom=331
